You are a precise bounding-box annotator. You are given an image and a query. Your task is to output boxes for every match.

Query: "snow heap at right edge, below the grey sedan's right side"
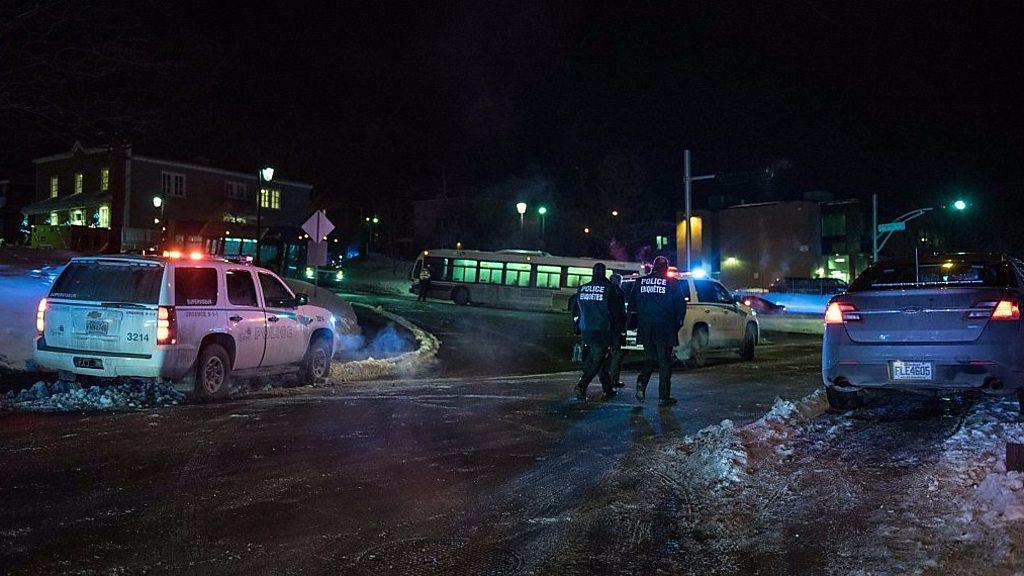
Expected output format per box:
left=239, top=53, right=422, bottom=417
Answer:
left=929, top=398, right=1024, bottom=522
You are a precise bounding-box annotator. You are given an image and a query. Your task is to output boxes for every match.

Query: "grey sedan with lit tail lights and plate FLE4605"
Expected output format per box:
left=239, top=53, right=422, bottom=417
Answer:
left=821, top=253, right=1024, bottom=409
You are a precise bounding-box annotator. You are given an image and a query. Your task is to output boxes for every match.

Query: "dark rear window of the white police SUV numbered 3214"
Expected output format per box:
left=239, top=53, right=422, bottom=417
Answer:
left=50, top=260, right=164, bottom=304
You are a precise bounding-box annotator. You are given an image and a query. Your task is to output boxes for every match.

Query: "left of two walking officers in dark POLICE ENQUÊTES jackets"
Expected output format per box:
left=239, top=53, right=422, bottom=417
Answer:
left=577, top=262, right=626, bottom=402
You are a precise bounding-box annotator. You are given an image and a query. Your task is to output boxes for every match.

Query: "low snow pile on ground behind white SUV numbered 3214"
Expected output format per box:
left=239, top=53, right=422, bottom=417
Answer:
left=0, top=380, right=184, bottom=412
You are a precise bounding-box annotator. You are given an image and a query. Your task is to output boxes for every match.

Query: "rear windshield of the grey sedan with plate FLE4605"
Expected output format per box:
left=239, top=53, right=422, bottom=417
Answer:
left=850, top=261, right=1017, bottom=292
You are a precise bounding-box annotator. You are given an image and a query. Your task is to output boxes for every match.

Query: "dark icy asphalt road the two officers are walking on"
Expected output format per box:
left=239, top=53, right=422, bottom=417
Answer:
left=0, top=293, right=818, bottom=574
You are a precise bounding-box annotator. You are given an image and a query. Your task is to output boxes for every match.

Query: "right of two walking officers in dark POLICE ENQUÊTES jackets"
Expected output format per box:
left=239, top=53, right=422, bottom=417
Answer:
left=629, top=256, right=686, bottom=406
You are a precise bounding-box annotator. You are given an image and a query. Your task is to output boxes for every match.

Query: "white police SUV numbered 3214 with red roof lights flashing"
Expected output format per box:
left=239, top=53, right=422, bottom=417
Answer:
left=35, top=251, right=335, bottom=399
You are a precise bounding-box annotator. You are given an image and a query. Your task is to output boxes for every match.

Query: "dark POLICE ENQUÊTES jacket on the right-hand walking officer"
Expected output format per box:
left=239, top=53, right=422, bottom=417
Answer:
left=629, top=273, right=686, bottom=346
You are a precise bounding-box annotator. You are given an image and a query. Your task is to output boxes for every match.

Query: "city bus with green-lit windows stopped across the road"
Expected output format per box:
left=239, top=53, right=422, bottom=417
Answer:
left=410, top=249, right=644, bottom=312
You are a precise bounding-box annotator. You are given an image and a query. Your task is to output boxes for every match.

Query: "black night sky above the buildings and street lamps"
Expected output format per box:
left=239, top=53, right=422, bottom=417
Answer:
left=2, top=0, right=1024, bottom=230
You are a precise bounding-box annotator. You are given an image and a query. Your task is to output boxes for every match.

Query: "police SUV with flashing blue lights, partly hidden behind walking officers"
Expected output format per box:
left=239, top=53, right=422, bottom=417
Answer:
left=622, top=273, right=761, bottom=367
